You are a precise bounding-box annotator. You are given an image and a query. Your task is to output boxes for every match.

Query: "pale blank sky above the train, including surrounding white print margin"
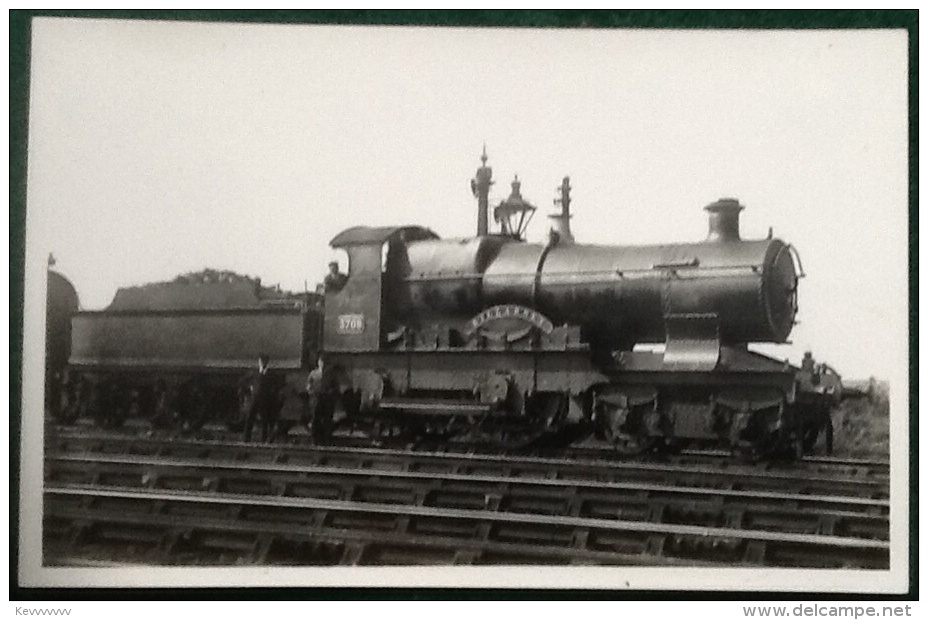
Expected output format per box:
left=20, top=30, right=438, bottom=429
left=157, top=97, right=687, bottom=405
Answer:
left=27, top=19, right=908, bottom=377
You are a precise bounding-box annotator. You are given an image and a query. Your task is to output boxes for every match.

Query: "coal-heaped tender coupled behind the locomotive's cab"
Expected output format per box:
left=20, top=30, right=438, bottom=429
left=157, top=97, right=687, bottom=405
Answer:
left=56, top=270, right=321, bottom=430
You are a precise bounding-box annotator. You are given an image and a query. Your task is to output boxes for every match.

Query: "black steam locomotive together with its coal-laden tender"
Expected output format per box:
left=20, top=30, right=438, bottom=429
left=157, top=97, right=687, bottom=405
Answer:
left=50, top=153, right=840, bottom=455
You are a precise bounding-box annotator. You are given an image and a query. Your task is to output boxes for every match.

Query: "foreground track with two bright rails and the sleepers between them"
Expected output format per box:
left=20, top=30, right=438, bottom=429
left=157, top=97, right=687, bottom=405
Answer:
left=46, top=455, right=889, bottom=540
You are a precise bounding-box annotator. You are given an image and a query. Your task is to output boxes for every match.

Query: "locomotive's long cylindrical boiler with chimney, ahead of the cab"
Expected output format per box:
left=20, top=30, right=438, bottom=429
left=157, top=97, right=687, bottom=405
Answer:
left=398, top=194, right=798, bottom=358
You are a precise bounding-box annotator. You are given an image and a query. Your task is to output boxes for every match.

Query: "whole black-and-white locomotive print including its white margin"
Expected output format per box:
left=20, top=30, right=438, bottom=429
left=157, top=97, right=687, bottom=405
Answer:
left=11, top=16, right=915, bottom=595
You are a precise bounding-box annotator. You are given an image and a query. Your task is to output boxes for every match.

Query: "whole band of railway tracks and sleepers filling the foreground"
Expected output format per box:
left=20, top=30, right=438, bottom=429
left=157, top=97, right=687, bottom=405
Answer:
left=45, top=434, right=889, bottom=568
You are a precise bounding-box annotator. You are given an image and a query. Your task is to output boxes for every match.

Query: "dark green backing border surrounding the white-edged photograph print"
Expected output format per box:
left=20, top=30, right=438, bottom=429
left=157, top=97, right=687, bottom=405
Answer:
left=9, top=9, right=919, bottom=601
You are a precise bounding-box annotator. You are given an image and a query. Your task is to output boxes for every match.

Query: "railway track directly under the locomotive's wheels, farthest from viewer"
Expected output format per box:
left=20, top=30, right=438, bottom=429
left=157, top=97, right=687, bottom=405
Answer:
left=47, top=431, right=889, bottom=499
